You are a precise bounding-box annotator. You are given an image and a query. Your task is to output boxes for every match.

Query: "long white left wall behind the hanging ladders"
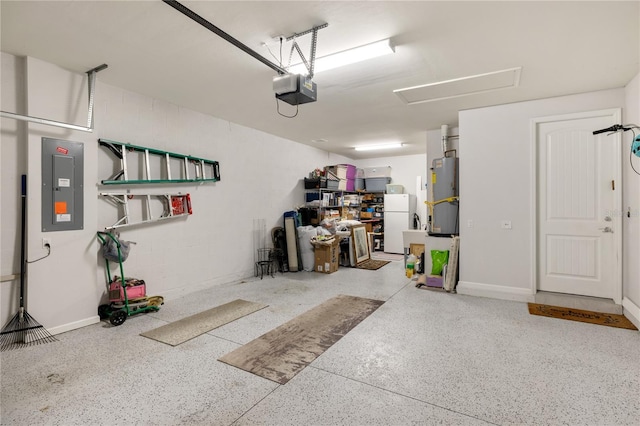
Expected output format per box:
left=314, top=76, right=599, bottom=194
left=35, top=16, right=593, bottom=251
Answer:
left=0, top=53, right=351, bottom=333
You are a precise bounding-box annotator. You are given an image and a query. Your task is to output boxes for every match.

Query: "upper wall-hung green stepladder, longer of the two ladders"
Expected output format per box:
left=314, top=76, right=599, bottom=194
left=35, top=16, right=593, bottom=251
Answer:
left=98, top=139, right=220, bottom=185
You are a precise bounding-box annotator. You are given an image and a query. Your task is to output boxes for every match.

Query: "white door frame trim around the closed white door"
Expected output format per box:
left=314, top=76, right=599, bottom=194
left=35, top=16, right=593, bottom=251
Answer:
left=530, top=108, right=623, bottom=305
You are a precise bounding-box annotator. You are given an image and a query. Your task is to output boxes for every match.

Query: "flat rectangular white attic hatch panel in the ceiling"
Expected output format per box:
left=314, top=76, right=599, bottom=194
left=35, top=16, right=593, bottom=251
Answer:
left=393, top=67, right=522, bottom=105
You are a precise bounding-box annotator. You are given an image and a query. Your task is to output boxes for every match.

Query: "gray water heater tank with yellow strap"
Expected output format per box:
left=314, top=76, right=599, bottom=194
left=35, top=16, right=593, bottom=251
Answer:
left=429, top=157, right=459, bottom=237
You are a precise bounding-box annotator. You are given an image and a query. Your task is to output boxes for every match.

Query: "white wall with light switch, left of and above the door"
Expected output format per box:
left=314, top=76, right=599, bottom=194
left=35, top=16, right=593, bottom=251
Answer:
left=458, top=89, right=638, bottom=301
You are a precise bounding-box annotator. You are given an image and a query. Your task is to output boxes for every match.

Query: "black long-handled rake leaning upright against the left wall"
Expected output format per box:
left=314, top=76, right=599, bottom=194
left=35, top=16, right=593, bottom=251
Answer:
left=0, top=175, right=58, bottom=352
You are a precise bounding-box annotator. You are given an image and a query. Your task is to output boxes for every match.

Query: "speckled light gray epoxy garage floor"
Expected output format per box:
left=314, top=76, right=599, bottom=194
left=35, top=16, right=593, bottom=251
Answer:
left=0, top=261, right=640, bottom=425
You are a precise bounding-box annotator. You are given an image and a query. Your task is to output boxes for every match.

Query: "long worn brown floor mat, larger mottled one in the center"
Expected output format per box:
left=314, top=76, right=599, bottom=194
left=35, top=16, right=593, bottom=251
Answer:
left=219, top=294, right=384, bottom=385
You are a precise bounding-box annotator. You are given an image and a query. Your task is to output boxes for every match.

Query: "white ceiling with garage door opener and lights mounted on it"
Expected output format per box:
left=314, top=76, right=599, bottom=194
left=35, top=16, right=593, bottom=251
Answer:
left=0, top=0, right=640, bottom=159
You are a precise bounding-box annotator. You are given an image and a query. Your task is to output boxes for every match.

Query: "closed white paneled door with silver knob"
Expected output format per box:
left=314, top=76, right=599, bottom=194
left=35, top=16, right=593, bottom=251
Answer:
left=535, top=109, right=622, bottom=303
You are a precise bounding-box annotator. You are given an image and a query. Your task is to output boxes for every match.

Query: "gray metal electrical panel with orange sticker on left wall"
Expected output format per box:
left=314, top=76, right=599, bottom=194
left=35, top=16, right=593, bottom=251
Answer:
left=42, top=138, right=84, bottom=232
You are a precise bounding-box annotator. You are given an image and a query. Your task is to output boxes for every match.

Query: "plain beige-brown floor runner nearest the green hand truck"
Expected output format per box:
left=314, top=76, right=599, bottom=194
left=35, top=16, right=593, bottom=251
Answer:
left=140, top=299, right=268, bottom=346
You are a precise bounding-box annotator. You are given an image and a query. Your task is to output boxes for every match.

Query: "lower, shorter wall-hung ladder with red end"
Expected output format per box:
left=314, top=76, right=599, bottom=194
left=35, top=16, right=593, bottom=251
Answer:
left=100, top=192, right=192, bottom=230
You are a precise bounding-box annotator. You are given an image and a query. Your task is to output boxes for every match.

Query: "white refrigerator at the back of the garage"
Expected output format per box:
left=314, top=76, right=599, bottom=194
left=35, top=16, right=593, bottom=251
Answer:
left=384, top=194, right=416, bottom=253
